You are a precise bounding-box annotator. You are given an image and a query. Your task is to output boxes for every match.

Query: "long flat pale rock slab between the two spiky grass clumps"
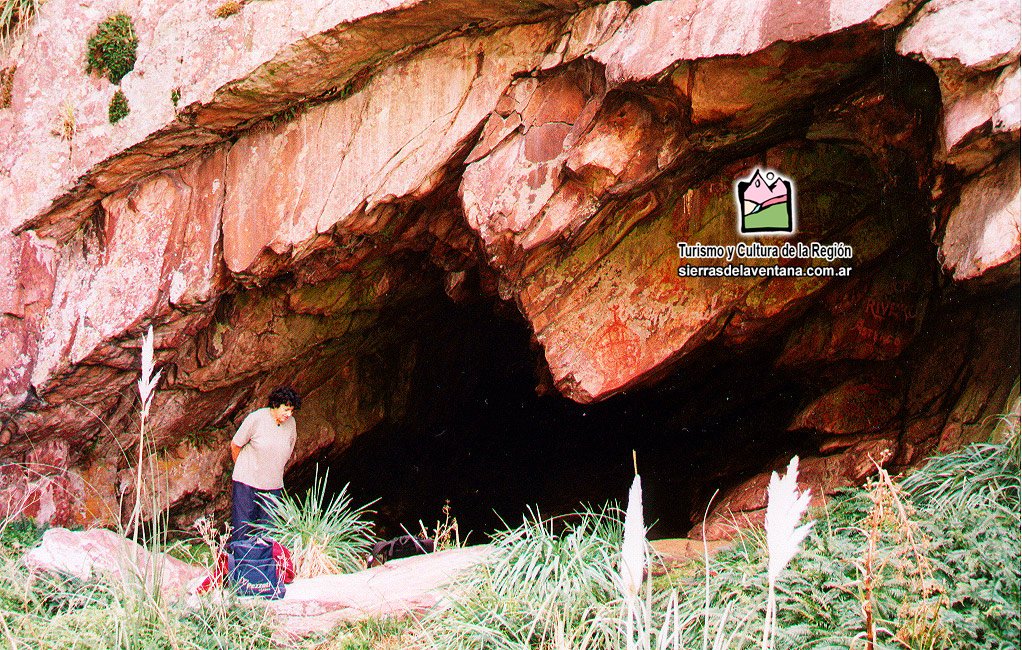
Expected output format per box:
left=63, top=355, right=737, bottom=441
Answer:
left=269, top=545, right=493, bottom=637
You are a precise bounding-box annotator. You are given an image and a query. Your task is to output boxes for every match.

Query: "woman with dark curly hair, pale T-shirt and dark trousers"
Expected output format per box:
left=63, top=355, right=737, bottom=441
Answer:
left=231, top=386, right=301, bottom=542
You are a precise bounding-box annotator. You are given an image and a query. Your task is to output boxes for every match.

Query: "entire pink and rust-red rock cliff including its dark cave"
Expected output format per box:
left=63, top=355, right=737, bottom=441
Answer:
left=0, top=0, right=1020, bottom=537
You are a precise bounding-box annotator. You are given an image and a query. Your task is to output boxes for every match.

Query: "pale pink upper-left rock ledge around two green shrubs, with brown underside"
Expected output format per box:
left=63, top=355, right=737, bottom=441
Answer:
left=0, top=0, right=596, bottom=239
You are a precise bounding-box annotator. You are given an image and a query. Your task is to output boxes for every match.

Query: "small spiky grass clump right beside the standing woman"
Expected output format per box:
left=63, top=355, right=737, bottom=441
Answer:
left=252, top=467, right=375, bottom=577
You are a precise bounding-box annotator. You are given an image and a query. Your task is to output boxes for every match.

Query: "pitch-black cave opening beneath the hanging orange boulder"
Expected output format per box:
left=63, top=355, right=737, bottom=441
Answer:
left=288, top=292, right=806, bottom=542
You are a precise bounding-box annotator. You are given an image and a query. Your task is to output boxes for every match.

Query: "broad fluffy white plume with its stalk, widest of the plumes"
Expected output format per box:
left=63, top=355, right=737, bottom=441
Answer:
left=762, top=456, right=812, bottom=649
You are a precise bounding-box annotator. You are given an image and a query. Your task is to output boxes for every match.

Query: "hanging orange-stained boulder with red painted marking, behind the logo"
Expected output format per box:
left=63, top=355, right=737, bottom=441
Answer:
left=510, top=133, right=912, bottom=401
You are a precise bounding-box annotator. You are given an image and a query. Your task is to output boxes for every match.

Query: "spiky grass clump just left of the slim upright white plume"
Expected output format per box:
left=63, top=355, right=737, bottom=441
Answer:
left=421, top=507, right=623, bottom=650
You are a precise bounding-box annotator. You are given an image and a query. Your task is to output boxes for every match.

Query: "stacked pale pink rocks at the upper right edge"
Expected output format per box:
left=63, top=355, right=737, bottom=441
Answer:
left=897, top=0, right=1020, bottom=282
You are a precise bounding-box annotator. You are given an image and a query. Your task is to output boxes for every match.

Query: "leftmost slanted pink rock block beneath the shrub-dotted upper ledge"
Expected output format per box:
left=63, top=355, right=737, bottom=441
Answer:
left=33, top=150, right=224, bottom=385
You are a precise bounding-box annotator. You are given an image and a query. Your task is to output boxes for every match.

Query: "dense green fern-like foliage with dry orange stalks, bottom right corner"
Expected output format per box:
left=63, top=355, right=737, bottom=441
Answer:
left=676, top=429, right=1022, bottom=648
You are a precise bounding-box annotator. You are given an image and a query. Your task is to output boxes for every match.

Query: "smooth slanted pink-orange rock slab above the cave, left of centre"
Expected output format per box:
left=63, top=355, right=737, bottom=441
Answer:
left=224, top=24, right=559, bottom=273
